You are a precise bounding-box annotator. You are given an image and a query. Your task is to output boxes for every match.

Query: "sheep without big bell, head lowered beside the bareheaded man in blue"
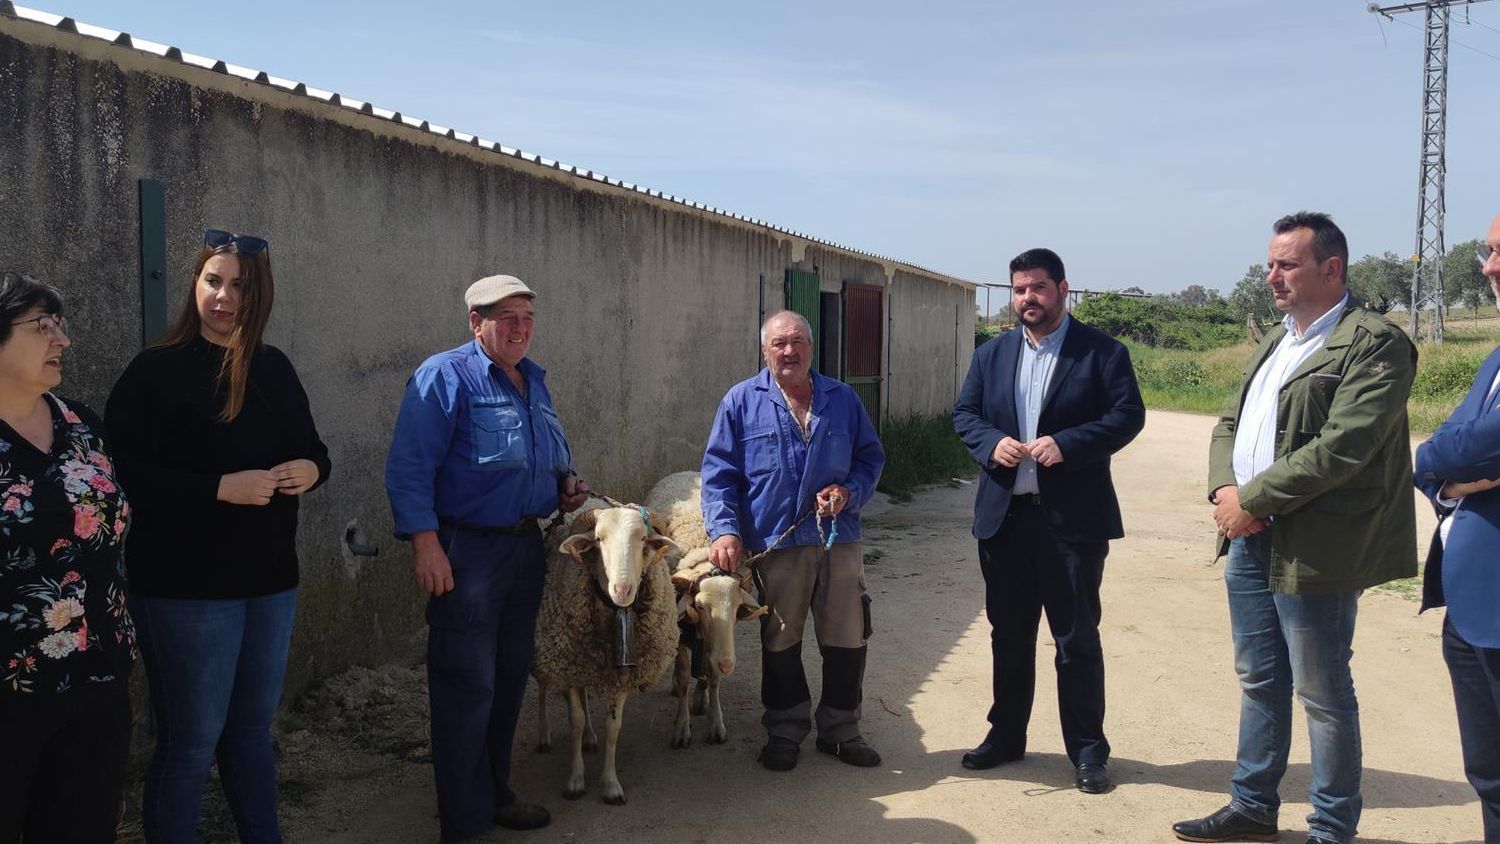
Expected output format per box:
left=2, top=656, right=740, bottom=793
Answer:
left=647, top=472, right=767, bottom=748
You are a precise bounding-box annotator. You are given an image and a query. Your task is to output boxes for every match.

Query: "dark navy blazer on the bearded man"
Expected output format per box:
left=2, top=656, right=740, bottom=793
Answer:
left=953, top=319, right=1146, bottom=543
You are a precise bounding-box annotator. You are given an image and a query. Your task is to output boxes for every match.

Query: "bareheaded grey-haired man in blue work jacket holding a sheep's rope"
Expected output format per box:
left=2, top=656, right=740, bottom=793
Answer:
left=702, top=310, right=885, bottom=771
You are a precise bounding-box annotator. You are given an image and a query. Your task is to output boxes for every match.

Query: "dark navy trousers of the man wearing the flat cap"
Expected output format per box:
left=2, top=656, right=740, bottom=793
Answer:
left=428, top=526, right=546, bottom=841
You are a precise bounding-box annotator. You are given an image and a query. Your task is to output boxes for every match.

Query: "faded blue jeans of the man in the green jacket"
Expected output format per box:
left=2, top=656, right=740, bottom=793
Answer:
left=1224, top=532, right=1364, bottom=843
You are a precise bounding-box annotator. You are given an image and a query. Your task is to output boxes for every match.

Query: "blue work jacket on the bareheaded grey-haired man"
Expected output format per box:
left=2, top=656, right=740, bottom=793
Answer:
left=702, top=369, right=885, bottom=552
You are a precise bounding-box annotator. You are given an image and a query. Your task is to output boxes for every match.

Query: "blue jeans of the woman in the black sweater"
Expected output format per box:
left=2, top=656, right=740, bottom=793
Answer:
left=131, top=589, right=297, bottom=844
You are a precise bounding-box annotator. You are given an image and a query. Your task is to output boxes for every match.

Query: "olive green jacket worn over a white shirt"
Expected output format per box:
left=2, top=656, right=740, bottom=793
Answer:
left=1209, top=304, right=1416, bottom=594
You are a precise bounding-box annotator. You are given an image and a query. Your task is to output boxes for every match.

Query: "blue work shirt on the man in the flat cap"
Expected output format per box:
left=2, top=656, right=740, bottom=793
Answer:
left=386, top=340, right=573, bottom=540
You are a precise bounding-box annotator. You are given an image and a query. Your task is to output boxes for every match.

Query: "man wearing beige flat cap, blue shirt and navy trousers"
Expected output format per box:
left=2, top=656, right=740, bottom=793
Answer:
left=386, top=276, right=588, bottom=841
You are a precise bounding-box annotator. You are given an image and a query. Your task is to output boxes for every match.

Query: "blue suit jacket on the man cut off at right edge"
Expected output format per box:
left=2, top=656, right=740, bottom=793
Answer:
left=1416, top=349, right=1500, bottom=648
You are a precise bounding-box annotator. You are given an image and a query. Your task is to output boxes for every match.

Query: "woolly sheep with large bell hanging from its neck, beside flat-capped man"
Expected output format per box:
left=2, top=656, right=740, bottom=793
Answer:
left=531, top=507, right=678, bottom=805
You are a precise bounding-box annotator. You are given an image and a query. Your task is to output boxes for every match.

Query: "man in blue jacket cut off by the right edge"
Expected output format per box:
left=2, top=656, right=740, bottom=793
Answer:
left=1416, top=217, right=1500, bottom=841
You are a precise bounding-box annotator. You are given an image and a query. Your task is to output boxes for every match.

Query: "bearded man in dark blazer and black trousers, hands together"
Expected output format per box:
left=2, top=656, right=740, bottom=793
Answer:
left=953, top=249, right=1146, bottom=795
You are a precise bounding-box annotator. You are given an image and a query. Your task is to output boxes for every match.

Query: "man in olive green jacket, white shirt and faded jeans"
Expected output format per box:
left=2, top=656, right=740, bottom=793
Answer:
left=1173, top=211, right=1416, bottom=844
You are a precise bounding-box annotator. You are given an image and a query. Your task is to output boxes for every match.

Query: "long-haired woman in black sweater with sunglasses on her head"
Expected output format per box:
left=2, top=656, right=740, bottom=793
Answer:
left=105, top=229, right=332, bottom=843
